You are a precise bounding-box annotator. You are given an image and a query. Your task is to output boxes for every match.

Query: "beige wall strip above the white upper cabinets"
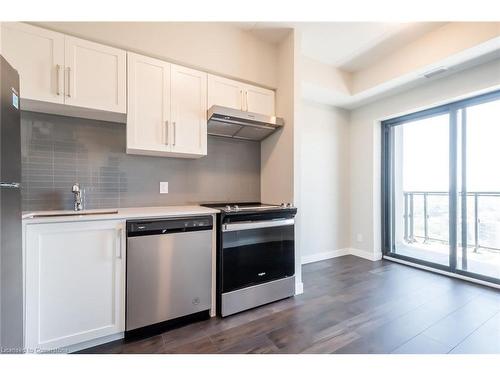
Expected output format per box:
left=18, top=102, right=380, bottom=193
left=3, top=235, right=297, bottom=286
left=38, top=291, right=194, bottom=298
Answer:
left=34, top=22, right=278, bottom=89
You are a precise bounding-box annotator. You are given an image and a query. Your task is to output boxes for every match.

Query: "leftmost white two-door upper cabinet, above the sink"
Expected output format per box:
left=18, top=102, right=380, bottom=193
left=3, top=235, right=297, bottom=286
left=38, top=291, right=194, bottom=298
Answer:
left=2, top=23, right=127, bottom=115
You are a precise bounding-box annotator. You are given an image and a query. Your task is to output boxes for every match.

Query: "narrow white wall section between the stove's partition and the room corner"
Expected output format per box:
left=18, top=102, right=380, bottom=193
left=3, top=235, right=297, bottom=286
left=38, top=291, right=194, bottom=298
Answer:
left=298, top=101, right=350, bottom=263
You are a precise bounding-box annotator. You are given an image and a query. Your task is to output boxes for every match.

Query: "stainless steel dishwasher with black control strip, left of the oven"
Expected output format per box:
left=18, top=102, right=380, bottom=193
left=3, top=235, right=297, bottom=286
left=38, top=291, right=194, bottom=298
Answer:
left=126, top=216, right=213, bottom=331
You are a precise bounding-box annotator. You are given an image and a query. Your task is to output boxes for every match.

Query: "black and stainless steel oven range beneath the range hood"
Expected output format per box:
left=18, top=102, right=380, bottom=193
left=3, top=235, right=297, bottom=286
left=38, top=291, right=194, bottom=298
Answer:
left=203, top=204, right=297, bottom=316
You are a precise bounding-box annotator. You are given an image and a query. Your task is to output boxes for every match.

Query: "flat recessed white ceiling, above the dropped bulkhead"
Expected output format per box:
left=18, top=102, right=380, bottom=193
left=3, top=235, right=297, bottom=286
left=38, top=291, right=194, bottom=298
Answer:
left=235, top=22, right=444, bottom=72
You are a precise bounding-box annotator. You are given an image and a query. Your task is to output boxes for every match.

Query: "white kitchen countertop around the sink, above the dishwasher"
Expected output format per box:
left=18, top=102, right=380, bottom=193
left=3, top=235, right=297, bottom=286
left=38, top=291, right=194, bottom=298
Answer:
left=23, top=206, right=219, bottom=224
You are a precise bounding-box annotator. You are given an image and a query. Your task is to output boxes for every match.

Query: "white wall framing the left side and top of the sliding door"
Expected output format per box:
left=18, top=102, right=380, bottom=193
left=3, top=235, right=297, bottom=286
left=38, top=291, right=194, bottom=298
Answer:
left=349, top=59, right=500, bottom=257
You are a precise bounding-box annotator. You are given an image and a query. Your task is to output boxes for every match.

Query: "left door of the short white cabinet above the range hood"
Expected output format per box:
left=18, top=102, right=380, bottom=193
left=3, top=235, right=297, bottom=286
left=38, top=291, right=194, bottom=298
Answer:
left=208, top=74, right=244, bottom=110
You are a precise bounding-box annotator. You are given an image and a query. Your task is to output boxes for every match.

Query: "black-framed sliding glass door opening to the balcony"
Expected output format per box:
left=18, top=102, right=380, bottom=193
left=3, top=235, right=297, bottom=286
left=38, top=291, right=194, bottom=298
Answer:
left=382, top=92, right=500, bottom=282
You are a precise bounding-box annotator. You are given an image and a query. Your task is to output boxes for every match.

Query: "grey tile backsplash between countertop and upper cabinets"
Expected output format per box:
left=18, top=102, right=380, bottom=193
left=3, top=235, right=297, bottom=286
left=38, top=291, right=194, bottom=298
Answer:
left=21, top=112, right=260, bottom=211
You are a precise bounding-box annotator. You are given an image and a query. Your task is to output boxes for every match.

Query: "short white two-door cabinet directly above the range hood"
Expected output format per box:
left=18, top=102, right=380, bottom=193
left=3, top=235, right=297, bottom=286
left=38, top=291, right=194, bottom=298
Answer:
left=208, top=74, right=275, bottom=116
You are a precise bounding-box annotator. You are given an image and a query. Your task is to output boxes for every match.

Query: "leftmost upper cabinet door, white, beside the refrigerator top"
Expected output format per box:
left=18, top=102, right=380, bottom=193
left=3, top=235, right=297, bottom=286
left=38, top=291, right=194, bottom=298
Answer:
left=2, top=23, right=64, bottom=105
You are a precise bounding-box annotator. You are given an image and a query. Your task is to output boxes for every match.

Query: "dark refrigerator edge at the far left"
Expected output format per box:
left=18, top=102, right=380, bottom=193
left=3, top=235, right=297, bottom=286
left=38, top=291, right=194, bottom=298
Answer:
left=0, top=56, right=23, bottom=352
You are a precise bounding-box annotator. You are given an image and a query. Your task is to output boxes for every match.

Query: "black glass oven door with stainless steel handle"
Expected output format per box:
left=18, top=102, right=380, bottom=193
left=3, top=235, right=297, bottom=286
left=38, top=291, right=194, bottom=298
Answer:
left=222, top=218, right=295, bottom=293
